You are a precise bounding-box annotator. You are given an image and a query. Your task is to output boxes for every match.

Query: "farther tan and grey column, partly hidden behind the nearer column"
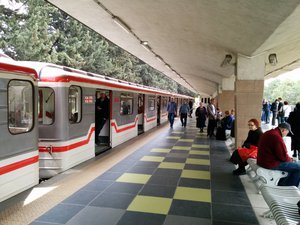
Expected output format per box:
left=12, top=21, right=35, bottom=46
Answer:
left=218, top=75, right=235, bottom=113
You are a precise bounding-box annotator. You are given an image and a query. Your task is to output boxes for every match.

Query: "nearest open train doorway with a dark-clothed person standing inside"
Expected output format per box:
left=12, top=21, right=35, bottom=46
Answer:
left=95, top=89, right=111, bottom=155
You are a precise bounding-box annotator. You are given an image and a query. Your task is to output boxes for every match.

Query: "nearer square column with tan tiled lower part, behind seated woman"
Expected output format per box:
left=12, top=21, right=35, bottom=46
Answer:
left=235, top=55, right=265, bottom=147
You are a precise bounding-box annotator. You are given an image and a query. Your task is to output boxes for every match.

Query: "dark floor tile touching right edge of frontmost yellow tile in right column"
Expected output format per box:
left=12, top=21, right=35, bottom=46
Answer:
left=212, top=191, right=250, bottom=206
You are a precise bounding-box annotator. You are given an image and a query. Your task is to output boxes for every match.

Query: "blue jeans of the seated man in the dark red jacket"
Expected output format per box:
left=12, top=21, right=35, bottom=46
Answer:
left=273, top=162, right=300, bottom=187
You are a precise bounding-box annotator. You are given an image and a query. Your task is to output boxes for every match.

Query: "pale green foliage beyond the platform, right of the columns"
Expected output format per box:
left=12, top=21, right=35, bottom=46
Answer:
left=264, top=79, right=300, bottom=105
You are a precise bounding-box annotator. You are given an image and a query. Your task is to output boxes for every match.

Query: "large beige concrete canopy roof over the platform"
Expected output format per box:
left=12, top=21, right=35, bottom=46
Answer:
left=48, top=0, right=300, bottom=96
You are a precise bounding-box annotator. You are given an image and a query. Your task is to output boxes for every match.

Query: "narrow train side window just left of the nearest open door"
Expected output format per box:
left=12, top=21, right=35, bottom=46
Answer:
left=69, top=86, right=81, bottom=123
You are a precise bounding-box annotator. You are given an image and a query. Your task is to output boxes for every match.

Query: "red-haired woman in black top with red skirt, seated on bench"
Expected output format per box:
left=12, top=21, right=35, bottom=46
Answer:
left=229, top=119, right=263, bottom=176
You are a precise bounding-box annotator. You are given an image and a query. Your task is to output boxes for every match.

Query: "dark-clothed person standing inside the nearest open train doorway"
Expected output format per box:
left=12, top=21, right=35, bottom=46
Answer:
left=95, top=92, right=109, bottom=145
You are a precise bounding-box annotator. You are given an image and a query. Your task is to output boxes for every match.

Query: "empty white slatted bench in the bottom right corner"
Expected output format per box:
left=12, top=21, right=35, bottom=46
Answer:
left=261, top=185, right=300, bottom=225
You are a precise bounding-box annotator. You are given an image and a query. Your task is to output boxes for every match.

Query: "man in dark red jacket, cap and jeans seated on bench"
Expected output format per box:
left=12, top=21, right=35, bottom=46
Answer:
left=257, top=123, right=300, bottom=187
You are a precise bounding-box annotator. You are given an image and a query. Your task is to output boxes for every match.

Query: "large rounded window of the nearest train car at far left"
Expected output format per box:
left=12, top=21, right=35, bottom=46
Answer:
left=8, top=80, right=34, bottom=134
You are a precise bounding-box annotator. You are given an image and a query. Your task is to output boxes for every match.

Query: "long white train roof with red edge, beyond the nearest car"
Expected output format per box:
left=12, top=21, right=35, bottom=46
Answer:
left=20, top=61, right=192, bottom=99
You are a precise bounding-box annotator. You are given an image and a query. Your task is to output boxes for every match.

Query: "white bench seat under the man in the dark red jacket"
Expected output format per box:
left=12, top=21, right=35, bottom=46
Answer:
left=247, top=158, right=288, bottom=192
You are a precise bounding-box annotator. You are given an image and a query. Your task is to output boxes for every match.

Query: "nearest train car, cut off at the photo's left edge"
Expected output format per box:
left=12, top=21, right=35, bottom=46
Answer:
left=0, top=55, right=39, bottom=202
